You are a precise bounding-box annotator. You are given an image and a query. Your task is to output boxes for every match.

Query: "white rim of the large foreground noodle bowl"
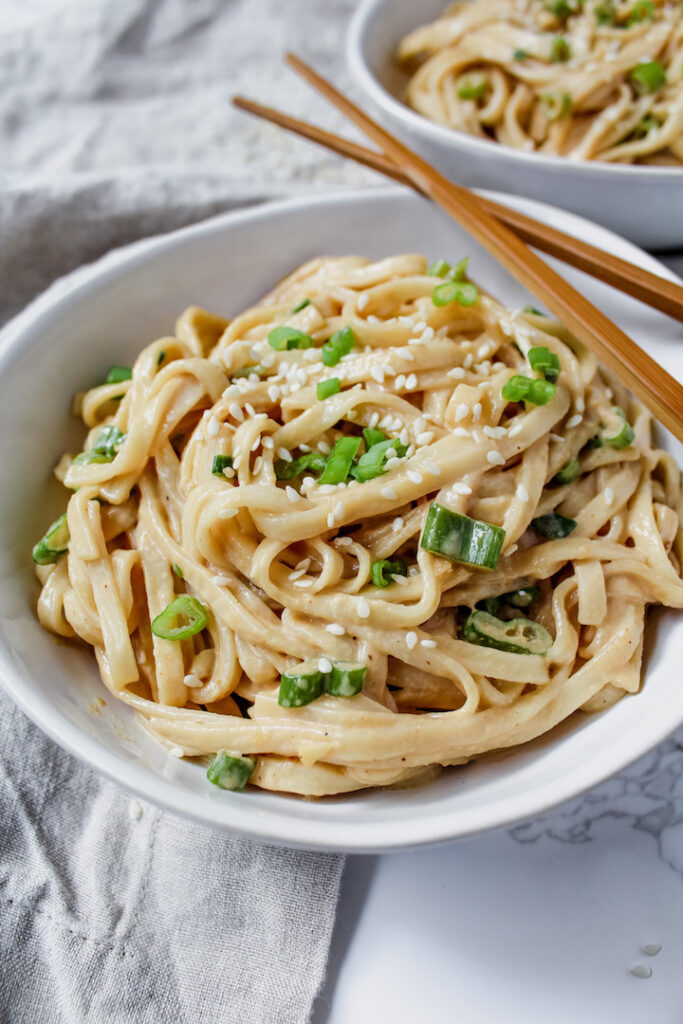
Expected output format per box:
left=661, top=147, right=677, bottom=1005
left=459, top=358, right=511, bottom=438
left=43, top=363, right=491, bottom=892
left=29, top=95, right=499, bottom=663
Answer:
left=0, top=186, right=683, bottom=853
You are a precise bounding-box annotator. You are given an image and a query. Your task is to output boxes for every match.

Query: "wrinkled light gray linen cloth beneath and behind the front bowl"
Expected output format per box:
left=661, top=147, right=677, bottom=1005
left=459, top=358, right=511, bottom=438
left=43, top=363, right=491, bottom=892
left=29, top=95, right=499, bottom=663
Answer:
left=0, top=0, right=372, bottom=1024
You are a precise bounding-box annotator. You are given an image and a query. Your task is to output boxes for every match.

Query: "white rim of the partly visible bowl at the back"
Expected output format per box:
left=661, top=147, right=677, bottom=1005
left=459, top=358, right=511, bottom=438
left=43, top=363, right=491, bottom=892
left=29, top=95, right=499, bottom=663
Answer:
left=345, top=0, right=683, bottom=184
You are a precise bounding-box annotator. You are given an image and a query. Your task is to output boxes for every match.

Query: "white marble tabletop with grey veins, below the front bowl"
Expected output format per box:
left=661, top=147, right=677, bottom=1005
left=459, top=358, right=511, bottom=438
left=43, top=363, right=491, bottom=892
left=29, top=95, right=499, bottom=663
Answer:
left=313, top=251, right=683, bottom=1024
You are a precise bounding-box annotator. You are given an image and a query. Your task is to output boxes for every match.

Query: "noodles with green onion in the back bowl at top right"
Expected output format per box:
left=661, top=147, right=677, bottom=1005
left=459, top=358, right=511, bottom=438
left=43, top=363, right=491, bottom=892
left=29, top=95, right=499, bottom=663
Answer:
left=398, top=0, right=683, bottom=166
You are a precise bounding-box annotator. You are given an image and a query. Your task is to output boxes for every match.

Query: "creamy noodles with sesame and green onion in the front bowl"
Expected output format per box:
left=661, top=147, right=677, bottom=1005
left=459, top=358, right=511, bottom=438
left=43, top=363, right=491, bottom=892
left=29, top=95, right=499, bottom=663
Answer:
left=34, top=255, right=683, bottom=796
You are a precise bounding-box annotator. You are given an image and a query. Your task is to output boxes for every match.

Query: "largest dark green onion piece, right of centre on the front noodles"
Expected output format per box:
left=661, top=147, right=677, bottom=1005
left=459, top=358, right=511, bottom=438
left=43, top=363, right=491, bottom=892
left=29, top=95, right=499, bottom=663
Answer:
left=420, top=502, right=505, bottom=569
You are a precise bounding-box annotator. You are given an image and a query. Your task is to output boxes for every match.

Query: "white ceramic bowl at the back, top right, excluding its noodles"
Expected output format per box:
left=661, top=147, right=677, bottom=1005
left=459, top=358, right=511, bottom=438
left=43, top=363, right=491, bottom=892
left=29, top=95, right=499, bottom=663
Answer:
left=346, top=0, right=683, bottom=249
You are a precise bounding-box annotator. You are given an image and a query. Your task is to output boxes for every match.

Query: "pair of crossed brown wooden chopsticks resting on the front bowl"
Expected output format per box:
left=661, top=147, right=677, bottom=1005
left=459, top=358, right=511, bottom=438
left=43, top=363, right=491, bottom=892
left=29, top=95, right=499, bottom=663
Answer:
left=233, top=54, right=683, bottom=441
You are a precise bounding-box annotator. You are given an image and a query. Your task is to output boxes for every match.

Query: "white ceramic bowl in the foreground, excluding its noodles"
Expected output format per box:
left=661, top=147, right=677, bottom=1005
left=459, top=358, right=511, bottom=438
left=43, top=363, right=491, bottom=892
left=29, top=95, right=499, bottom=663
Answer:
left=0, top=188, right=683, bottom=851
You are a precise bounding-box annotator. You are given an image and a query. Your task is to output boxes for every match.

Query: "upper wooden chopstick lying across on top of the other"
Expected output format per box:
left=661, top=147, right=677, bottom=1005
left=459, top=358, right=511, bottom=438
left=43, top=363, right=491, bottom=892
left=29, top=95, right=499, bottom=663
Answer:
left=286, top=53, right=683, bottom=441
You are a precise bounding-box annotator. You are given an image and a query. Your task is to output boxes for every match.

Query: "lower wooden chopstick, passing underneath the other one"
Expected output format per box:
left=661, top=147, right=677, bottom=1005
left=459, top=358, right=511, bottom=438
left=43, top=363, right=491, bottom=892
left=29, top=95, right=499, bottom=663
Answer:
left=232, top=96, right=683, bottom=323
